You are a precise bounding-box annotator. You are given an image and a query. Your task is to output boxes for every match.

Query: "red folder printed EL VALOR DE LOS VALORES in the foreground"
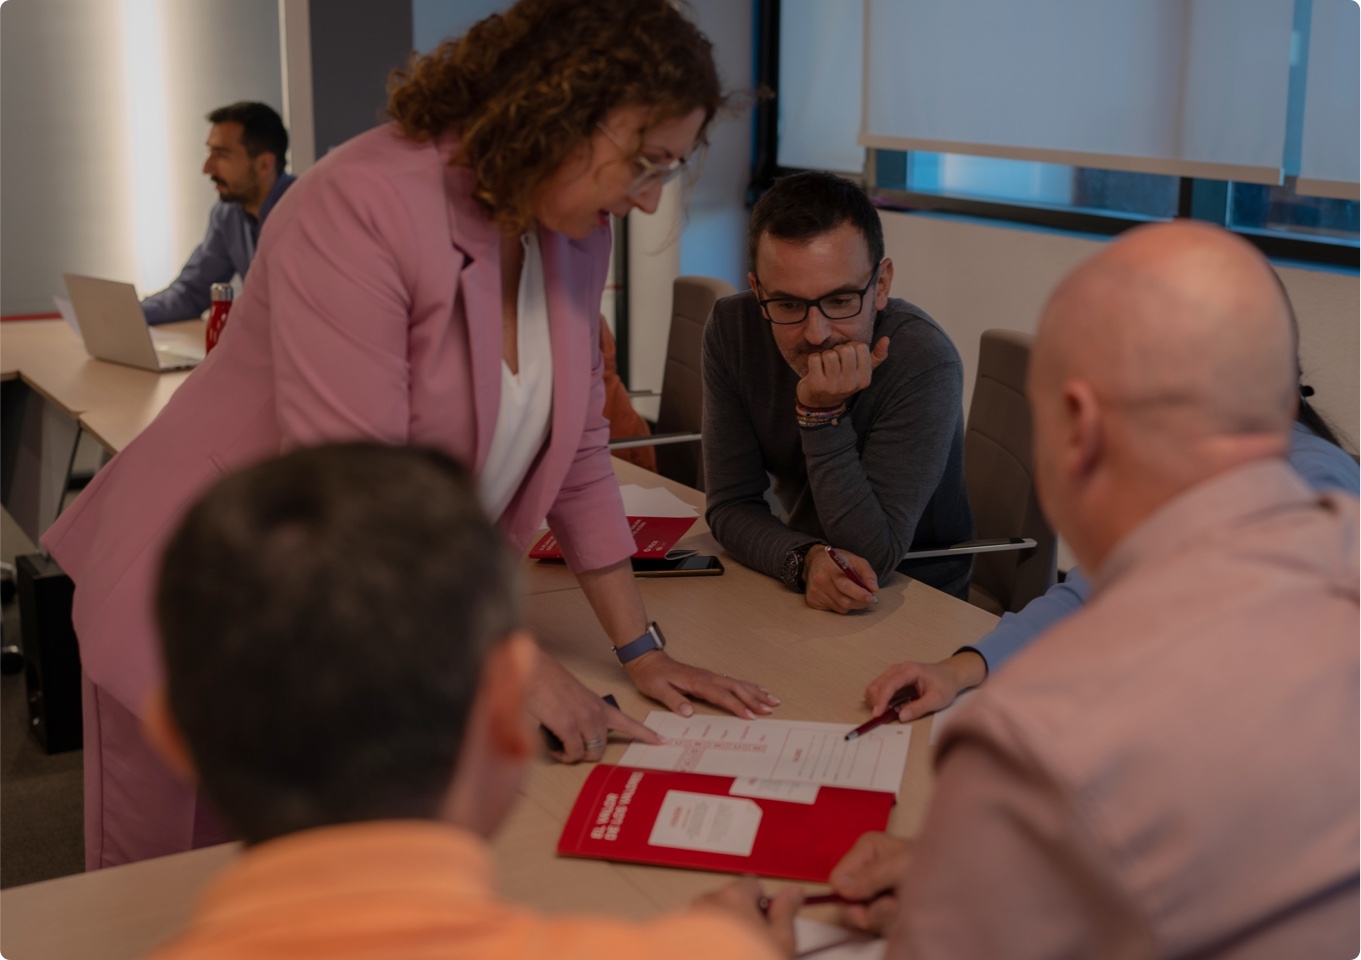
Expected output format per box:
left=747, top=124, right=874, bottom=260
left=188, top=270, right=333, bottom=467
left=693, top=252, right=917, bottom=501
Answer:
left=558, top=764, right=893, bottom=882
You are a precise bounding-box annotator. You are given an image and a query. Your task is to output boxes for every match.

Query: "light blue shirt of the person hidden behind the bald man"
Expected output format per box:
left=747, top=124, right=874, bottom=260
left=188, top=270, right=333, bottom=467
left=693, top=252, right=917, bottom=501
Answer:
left=961, top=423, right=1361, bottom=674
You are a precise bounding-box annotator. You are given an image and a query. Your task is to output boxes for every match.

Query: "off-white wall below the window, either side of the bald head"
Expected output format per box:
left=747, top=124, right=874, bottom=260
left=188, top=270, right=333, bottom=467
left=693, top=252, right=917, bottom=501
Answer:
left=881, top=212, right=1361, bottom=449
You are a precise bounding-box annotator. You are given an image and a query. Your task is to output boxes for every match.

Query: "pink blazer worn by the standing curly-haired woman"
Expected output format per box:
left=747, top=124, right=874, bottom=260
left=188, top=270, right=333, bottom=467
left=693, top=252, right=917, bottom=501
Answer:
left=42, top=125, right=633, bottom=712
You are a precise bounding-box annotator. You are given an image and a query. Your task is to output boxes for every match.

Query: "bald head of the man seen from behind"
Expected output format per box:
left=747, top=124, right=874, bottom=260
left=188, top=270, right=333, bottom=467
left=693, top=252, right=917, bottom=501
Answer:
left=1030, top=221, right=1297, bottom=561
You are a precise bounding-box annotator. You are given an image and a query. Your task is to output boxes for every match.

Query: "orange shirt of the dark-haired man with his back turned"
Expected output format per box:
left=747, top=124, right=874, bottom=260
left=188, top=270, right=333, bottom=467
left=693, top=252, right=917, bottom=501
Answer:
left=146, top=821, right=776, bottom=960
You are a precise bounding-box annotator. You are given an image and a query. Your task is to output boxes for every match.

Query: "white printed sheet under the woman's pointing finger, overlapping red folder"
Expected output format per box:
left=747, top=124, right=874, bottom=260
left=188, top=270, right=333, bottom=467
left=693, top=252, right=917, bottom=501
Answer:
left=619, top=711, right=912, bottom=797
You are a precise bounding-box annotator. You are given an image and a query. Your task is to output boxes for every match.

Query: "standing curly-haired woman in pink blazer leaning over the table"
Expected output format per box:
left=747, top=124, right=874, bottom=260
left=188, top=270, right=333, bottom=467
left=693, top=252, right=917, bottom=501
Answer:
left=44, top=0, right=777, bottom=869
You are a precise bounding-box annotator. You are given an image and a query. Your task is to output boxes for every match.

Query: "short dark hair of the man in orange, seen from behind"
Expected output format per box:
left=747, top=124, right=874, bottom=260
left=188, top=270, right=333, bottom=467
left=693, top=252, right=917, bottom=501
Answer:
left=157, top=444, right=520, bottom=843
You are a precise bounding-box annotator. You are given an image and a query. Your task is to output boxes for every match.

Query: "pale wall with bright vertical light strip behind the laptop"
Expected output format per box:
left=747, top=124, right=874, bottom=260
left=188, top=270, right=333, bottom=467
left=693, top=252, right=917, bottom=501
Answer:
left=0, top=0, right=282, bottom=315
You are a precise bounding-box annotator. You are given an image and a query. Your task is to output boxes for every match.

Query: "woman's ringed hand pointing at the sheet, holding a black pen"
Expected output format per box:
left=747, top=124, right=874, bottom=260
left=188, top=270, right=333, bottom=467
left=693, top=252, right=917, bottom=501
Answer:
left=529, top=650, right=661, bottom=764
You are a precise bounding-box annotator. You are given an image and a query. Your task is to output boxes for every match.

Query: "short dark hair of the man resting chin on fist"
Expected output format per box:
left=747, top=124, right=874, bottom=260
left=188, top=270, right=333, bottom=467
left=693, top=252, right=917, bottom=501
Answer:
left=747, top=170, right=883, bottom=274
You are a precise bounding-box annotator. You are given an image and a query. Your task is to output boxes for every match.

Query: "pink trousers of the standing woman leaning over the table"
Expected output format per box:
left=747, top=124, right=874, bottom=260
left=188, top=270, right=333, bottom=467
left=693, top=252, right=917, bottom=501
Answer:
left=80, top=673, right=233, bottom=870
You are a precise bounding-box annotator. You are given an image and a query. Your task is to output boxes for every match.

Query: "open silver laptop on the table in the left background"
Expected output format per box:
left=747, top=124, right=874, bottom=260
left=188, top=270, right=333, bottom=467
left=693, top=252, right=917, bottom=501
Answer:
left=63, top=274, right=203, bottom=373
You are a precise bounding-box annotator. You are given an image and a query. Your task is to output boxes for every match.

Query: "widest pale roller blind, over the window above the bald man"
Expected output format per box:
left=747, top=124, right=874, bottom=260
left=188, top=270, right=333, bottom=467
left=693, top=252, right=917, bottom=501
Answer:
left=859, top=0, right=1295, bottom=184
